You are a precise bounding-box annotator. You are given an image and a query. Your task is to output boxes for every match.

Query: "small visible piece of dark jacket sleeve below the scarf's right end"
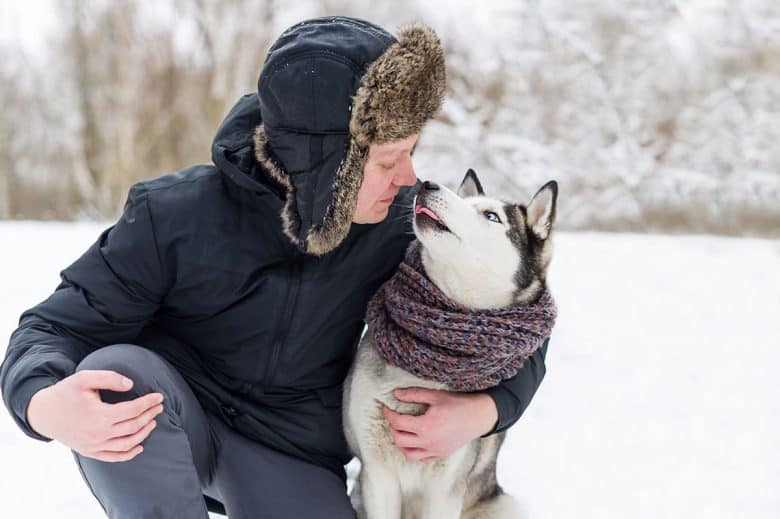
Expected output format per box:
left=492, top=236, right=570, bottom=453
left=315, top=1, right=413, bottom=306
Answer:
left=485, top=337, right=550, bottom=436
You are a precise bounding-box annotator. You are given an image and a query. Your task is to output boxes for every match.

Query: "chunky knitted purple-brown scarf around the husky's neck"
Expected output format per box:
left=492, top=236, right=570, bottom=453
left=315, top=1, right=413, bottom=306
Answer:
left=366, top=240, right=556, bottom=391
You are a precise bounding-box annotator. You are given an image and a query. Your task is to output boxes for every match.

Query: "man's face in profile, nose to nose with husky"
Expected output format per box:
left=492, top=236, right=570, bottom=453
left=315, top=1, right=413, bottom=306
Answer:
left=352, top=133, right=418, bottom=223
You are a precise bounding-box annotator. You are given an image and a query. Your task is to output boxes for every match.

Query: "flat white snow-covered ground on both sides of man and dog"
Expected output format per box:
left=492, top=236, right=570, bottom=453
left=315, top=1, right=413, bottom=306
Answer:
left=0, top=222, right=780, bottom=519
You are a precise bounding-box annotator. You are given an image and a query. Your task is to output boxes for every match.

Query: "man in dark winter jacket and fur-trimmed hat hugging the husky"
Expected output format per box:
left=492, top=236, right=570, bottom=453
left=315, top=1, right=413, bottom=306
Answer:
left=0, top=17, right=545, bottom=518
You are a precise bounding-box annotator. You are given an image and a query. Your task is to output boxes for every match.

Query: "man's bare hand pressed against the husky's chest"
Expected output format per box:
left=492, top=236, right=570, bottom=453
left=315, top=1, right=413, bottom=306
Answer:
left=383, top=388, right=498, bottom=461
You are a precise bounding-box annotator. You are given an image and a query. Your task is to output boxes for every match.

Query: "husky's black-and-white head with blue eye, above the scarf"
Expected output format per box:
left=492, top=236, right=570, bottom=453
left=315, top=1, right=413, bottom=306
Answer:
left=414, top=169, right=558, bottom=309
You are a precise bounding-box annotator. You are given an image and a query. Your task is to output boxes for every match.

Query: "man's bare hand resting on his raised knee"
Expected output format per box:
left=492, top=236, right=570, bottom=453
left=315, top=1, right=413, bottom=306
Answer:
left=27, top=370, right=163, bottom=462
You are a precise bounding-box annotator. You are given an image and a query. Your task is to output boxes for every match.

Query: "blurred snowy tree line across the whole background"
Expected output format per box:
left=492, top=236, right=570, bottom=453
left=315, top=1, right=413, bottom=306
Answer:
left=0, top=0, right=780, bottom=237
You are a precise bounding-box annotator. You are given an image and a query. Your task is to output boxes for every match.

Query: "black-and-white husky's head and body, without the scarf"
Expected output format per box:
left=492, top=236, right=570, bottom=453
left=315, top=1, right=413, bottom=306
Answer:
left=343, top=169, right=558, bottom=519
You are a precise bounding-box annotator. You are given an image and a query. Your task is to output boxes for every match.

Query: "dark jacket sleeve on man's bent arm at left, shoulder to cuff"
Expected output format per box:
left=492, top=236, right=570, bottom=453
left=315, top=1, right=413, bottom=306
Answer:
left=0, top=185, right=166, bottom=441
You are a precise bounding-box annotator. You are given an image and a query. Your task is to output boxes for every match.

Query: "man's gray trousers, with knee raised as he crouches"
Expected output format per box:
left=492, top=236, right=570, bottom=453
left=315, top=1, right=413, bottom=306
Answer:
left=74, top=344, right=354, bottom=519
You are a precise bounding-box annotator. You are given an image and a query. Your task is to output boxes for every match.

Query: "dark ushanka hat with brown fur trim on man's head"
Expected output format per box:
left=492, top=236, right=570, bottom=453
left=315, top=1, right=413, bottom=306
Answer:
left=254, top=17, right=445, bottom=255
